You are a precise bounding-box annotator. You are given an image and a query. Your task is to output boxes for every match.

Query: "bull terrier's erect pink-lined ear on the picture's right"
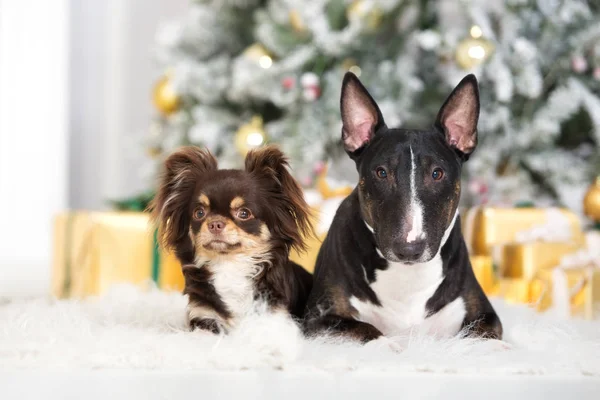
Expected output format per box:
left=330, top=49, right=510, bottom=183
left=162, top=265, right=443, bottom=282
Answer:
left=436, top=74, right=479, bottom=156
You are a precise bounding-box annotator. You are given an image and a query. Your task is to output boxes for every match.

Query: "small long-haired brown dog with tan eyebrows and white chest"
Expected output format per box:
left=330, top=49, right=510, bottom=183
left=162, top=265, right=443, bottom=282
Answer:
left=151, top=146, right=313, bottom=333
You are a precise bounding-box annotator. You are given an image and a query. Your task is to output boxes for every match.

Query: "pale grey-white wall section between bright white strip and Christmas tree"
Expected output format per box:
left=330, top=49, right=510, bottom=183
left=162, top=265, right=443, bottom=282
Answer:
left=69, top=0, right=189, bottom=209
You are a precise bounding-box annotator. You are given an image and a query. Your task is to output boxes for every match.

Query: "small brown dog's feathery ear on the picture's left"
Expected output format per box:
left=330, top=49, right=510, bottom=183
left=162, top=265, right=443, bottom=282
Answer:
left=149, top=146, right=217, bottom=248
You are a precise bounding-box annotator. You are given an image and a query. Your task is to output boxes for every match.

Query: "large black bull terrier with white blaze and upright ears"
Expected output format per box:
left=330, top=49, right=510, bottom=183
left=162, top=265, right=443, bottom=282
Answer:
left=304, top=73, right=502, bottom=342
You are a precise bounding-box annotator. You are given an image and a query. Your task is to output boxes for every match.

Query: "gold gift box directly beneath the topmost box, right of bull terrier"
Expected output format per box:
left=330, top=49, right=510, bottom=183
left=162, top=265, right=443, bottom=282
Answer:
left=494, top=242, right=581, bottom=281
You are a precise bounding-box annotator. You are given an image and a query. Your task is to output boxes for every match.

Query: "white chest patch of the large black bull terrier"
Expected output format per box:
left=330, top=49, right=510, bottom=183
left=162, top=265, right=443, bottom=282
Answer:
left=350, top=254, right=466, bottom=336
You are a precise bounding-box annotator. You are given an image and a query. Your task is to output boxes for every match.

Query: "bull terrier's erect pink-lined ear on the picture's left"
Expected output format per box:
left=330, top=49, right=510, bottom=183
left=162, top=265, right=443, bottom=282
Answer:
left=340, top=72, right=384, bottom=156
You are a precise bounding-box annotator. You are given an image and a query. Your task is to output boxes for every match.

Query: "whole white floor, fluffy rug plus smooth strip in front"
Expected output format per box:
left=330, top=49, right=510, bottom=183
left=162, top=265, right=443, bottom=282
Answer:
left=0, top=286, right=600, bottom=400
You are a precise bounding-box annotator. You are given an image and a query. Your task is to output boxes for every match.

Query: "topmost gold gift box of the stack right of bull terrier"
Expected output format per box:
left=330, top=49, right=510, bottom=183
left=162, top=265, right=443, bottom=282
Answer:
left=461, top=207, right=584, bottom=255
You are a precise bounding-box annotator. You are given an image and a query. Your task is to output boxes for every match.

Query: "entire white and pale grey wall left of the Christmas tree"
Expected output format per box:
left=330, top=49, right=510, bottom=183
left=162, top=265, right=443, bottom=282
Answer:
left=0, top=0, right=189, bottom=296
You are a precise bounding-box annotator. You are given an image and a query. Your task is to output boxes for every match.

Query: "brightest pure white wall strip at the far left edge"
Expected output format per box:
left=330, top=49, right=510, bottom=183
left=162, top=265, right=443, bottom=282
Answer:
left=0, top=0, right=69, bottom=294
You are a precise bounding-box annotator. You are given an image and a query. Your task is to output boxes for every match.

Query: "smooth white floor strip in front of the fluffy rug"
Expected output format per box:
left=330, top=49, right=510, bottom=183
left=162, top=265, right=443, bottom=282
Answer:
left=0, top=370, right=600, bottom=400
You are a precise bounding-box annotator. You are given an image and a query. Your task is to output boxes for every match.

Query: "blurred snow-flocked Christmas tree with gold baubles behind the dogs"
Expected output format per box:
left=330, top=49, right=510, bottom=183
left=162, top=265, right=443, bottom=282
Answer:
left=149, top=0, right=600, bottom=212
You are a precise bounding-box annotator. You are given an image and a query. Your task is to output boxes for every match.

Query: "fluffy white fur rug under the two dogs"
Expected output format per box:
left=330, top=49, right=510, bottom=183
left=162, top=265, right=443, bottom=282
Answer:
left=0, top=286, right=600, bottom=377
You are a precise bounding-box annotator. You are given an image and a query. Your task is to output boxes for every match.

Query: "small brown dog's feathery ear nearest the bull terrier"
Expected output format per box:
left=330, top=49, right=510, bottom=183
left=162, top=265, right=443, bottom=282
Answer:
left=246, top=145, right=314, bottom=250
